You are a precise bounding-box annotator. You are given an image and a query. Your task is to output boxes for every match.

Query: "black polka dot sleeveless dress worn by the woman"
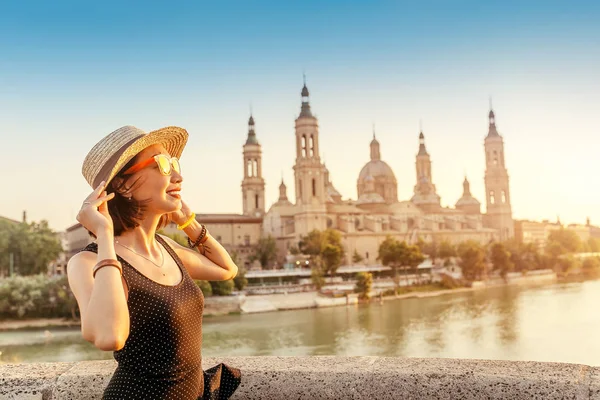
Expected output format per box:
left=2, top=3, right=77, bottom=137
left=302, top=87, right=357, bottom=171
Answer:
left=82, top=235, right=240, bottom=400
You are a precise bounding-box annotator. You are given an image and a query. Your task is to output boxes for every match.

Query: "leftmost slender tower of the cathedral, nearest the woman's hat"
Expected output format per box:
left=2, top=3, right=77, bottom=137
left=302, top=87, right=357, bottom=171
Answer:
left=242, top=115, right=265, bottom=216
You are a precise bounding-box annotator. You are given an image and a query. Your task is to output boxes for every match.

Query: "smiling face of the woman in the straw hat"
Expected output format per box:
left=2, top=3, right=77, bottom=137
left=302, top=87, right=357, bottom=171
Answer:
left=125, top=145, right=183, bottom=214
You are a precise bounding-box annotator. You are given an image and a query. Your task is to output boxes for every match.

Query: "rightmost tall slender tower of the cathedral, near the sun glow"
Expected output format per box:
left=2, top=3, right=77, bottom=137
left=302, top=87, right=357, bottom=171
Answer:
left=484, top=107, right=514, bottom=240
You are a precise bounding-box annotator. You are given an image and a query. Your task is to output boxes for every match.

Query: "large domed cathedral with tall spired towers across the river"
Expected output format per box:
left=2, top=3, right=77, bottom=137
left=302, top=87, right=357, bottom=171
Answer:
left=242, top=84, right=514, bottom=263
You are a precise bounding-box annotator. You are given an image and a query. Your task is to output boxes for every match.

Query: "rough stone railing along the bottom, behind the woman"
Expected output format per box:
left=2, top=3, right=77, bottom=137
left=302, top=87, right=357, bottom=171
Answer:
left=0, top=357, right=600, bottom=400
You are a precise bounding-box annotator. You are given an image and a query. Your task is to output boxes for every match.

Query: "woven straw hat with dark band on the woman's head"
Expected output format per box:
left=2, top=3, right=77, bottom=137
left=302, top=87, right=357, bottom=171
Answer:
left=81, top=126, right=188, bottom=188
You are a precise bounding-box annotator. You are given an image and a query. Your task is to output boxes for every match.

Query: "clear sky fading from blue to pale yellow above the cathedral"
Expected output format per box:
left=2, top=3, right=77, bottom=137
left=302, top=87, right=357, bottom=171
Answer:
left=0, top=0, right=600, bottom=230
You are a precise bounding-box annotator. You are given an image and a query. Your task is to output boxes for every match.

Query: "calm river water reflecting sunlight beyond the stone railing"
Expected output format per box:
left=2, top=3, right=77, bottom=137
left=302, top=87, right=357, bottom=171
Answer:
left=0, top=281, right=600, bottom=366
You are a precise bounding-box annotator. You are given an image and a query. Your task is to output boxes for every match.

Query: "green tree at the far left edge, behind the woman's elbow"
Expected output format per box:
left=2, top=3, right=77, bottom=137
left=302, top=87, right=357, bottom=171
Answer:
left=0, top=220, right=63, bottom=275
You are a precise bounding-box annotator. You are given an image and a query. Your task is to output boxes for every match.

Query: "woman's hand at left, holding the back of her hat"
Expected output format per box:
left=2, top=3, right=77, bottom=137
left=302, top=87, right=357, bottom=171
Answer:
left=77, top=181, right=115, bottom=237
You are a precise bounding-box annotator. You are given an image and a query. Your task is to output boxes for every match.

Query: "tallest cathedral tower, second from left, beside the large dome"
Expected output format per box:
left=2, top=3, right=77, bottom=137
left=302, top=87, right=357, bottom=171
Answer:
left=294, top=82, right=327, bottom=234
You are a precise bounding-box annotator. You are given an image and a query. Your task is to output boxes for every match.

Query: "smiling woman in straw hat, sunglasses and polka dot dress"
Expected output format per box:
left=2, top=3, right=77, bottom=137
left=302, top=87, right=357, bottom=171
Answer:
left=67, top=126, right=240, bottom=399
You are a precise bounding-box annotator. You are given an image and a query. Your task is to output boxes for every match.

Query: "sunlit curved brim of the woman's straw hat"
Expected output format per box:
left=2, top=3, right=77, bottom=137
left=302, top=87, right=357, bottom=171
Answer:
left=94, top=126, right=188, bottom=186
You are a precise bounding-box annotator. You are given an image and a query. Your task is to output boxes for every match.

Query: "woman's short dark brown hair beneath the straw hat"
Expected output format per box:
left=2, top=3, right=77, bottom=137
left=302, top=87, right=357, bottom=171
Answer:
left=88, top=156, right=171, bottom=238
